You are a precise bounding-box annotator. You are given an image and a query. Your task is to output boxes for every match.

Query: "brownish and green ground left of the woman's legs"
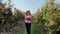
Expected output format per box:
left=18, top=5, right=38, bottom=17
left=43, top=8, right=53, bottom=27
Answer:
left=1, top=23, right=26, bottom=34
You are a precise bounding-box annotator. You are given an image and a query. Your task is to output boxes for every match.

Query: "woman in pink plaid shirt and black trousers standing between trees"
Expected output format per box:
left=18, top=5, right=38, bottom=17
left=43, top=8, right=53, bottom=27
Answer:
left=25, top=11, right=32, bottom=34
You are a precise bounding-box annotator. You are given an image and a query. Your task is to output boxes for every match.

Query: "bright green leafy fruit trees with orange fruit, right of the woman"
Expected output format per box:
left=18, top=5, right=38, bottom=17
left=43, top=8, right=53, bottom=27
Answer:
left=34, top=2, right=60, bottom=34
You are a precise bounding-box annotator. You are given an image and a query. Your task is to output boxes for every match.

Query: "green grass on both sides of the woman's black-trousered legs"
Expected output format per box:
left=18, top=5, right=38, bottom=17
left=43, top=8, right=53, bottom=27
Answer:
left=17, top=22, right=44, bottom=34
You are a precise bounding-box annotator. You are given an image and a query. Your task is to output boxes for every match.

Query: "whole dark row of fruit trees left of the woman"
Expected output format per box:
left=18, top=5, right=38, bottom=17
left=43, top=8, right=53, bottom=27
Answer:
left=0, top=4, right=24, bottom=32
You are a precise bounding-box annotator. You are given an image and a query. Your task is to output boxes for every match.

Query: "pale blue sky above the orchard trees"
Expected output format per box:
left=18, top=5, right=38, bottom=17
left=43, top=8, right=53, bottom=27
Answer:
left=3, top=0, right=60, bottom=13
